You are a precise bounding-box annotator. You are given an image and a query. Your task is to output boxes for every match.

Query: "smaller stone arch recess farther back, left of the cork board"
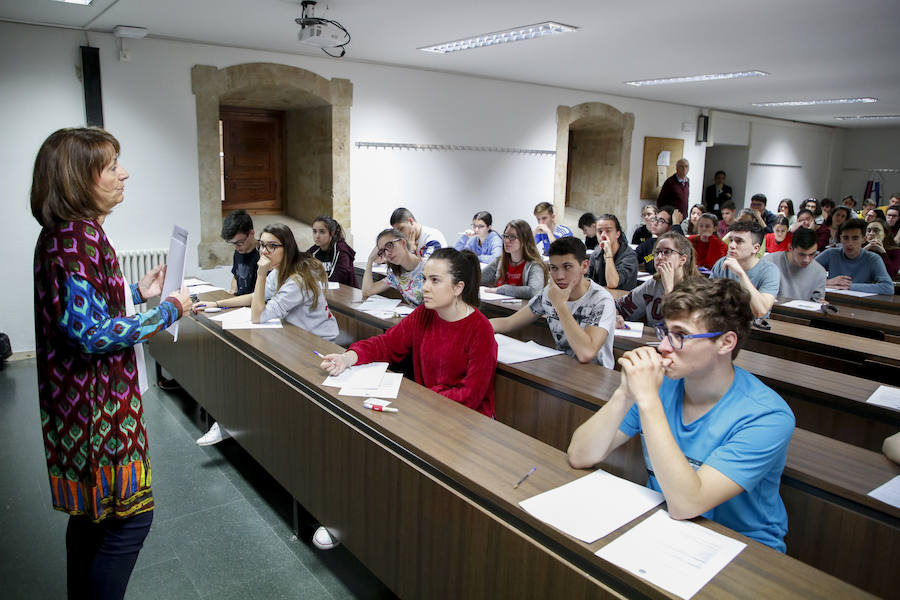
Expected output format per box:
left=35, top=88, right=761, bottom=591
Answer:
left=553, top=102, right=634, bottom=227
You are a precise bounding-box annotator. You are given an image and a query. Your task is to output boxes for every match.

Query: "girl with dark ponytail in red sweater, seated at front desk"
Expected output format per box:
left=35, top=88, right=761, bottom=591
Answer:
left=322, top=248, right=497, bottom=417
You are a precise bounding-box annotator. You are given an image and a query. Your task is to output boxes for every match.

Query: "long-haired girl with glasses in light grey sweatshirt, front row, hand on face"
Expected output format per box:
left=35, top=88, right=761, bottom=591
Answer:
left=193, top=223, right=338, bottom=340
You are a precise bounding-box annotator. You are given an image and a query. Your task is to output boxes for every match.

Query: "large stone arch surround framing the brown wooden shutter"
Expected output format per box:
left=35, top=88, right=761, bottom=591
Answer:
left=191, top=63, right=353, bottom=268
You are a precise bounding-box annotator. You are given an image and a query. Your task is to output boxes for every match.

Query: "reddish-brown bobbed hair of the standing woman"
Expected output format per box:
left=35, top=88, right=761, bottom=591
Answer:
left=31, top=127, right=119, bottom=227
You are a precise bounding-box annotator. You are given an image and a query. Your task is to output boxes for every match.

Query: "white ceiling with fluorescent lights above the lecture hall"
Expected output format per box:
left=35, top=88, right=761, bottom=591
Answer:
left=0, top=0, right=900, bottom=127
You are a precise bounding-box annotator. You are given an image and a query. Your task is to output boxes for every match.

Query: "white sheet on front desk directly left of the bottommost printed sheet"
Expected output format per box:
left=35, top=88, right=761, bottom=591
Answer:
left=519, top=469, right=663, bottom=544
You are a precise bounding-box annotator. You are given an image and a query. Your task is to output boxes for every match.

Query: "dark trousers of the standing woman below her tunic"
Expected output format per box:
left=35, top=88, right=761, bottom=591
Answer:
left=66, top=510, right=153, bottom=600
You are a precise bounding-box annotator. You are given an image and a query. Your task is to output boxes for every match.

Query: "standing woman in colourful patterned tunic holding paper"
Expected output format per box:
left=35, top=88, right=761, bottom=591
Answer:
left=31, top=127, right=190, bottom=598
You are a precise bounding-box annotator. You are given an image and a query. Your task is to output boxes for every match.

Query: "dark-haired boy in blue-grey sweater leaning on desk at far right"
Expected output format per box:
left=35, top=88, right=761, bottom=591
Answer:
left=816, top=219, right=894, bottom=296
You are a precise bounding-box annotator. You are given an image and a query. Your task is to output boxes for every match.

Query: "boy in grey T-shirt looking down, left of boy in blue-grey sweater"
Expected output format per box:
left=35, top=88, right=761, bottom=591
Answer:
left=763, top=227, right=827, bottom=301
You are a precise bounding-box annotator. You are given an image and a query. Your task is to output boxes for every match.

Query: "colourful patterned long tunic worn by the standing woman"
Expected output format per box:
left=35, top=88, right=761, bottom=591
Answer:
left=34, top=221, right=181, bottom=521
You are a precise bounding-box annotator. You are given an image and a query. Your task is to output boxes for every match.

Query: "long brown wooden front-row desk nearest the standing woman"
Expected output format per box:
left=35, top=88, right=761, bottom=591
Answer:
left=150, top=295, right=869, bottom=599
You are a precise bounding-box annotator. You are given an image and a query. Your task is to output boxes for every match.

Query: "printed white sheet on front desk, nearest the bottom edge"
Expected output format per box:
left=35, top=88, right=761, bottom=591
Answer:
left=596, top=510, right=747, bottom=600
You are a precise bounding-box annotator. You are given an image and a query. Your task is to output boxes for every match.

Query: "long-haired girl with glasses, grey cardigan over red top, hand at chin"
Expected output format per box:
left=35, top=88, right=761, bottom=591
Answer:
left=481, top=219, right=550, bottom=300
